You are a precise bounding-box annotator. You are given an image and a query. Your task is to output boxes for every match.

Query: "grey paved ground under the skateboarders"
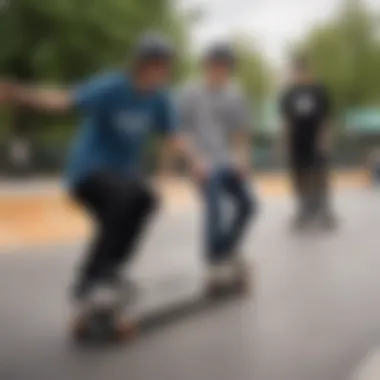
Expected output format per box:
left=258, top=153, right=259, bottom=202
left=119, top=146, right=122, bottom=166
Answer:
left=0, top=190, right=380, bottom=380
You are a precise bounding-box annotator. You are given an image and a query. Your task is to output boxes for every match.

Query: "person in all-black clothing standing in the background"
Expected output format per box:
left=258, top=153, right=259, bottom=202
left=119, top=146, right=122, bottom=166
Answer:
left=280, top=57, right=335, bottom=227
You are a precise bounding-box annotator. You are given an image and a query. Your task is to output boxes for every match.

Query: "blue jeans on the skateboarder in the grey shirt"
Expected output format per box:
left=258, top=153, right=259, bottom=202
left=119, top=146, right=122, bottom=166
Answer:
left=203, top=167, right=257, bottom=263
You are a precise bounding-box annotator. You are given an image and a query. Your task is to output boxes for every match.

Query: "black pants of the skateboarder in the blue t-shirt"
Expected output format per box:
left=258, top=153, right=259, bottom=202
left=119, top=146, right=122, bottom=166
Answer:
left=73, top=172, right=157, bottom=281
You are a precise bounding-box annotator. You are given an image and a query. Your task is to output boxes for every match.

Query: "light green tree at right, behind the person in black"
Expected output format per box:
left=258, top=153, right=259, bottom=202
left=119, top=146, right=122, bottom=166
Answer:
left=301, top=0, right=380, bottom=114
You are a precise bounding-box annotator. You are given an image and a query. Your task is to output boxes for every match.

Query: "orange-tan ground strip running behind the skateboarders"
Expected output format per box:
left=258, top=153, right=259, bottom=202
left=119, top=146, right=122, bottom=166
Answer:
left=0, top=171, right=368, bottom=252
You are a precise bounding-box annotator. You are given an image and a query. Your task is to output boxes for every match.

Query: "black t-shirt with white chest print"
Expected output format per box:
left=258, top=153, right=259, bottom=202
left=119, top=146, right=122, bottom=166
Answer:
left=280, top=83, right=330, bottom=133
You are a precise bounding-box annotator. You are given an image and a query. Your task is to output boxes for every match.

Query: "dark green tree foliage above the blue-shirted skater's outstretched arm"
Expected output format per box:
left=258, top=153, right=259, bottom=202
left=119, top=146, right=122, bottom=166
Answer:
left=0, top=0, right=190, bottom=82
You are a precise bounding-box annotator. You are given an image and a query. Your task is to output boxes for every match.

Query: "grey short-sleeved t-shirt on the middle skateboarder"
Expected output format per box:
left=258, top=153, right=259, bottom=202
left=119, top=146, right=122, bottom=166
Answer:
left=178, top=81, right=252, bottom=166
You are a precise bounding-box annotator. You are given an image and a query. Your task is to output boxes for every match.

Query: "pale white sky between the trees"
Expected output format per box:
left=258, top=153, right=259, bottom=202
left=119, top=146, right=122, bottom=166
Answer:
left=177, top=0, right=380, bottom=64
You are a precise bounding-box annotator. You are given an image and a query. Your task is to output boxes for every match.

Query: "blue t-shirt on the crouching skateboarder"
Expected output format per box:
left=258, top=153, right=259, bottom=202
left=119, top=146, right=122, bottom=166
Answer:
left=67, top=73, right=176, bottom=186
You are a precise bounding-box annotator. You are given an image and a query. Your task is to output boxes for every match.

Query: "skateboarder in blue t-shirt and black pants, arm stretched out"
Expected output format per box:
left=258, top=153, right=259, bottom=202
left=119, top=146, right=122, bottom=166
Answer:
left=0, top=34, right=184, bottom=300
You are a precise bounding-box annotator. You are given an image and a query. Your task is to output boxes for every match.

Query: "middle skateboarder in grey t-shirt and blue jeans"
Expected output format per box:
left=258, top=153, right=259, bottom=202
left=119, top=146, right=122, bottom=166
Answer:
left=179, top=44, right=256, bottom=285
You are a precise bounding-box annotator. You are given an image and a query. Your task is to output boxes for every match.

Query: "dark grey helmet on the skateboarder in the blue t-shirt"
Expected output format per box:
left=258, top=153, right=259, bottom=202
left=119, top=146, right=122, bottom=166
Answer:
left=134, top=33, right=175, bottom=63
